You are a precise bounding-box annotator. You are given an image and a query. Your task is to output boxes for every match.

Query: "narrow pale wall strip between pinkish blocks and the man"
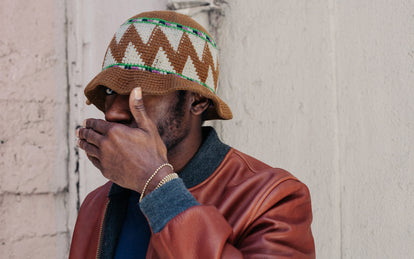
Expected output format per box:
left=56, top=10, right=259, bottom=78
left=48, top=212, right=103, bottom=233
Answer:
left=67, top=0, right=168, bottom=241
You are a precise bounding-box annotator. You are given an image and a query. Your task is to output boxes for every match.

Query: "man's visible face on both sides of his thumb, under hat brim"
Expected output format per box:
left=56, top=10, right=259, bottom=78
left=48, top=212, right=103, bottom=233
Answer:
left=105, top=88, right=190, bottom=150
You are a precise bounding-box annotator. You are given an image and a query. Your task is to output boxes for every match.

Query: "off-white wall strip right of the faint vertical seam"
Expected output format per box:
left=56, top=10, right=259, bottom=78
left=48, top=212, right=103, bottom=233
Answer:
left=335, top=0, right=414, bottom=258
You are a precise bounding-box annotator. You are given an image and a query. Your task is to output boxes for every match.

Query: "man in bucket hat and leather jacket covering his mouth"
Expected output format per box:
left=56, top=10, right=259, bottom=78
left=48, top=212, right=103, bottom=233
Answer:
left=70, top=11, right=315, bottom=259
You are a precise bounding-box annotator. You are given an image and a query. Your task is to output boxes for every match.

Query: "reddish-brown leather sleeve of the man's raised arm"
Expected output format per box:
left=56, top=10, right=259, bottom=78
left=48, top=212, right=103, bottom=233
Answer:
left=147, top=178, right=315, bottom=259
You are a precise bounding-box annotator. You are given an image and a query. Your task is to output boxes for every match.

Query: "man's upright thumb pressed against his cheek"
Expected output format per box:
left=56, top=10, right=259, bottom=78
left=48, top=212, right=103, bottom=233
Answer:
left=129, top=87, right=150, bottom=130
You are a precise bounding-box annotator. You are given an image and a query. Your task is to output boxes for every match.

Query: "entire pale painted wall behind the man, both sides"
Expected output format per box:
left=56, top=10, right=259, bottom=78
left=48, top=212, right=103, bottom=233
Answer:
left=0, top=0, right=414, bottom=258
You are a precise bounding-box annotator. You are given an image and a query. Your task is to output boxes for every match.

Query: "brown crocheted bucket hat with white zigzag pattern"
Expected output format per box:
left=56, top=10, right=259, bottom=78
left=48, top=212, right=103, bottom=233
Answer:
left=85, top=11, right=233, bottom=120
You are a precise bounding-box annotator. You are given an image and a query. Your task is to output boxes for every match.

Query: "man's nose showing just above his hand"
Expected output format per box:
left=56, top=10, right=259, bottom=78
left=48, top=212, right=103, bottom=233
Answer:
left=105, top=94, right=132, bottom=124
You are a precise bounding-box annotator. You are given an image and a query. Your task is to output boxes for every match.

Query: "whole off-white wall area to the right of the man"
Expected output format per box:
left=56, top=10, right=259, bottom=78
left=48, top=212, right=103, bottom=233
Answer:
left=218, top=0, right=414, bottom=258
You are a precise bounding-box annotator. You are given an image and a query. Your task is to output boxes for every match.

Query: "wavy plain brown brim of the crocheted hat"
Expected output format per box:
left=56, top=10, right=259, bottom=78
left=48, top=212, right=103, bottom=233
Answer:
left=85, top=67, right=233, bottom=120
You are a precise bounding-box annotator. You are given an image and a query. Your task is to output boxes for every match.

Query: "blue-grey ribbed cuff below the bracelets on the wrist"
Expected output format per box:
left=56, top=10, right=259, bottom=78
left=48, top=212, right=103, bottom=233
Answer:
left=139, top=178, right=200, bottom=233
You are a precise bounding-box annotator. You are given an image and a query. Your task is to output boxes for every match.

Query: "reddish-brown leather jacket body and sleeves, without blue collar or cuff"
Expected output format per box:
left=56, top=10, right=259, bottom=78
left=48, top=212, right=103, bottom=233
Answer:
left=70, top=129, right=315, bottom=259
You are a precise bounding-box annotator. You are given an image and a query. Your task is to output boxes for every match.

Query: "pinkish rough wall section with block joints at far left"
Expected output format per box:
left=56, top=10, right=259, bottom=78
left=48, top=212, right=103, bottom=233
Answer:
left=0, top=0, right=68, bottom=258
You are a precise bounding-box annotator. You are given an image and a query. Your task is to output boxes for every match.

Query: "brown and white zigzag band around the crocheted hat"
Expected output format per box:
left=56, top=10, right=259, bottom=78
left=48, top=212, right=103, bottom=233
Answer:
left=102, top=18, right=218, bottom=92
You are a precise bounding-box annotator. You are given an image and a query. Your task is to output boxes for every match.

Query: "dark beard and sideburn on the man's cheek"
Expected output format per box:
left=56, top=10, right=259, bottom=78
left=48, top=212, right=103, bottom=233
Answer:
left=157, top=91, right=190, bottom=152
